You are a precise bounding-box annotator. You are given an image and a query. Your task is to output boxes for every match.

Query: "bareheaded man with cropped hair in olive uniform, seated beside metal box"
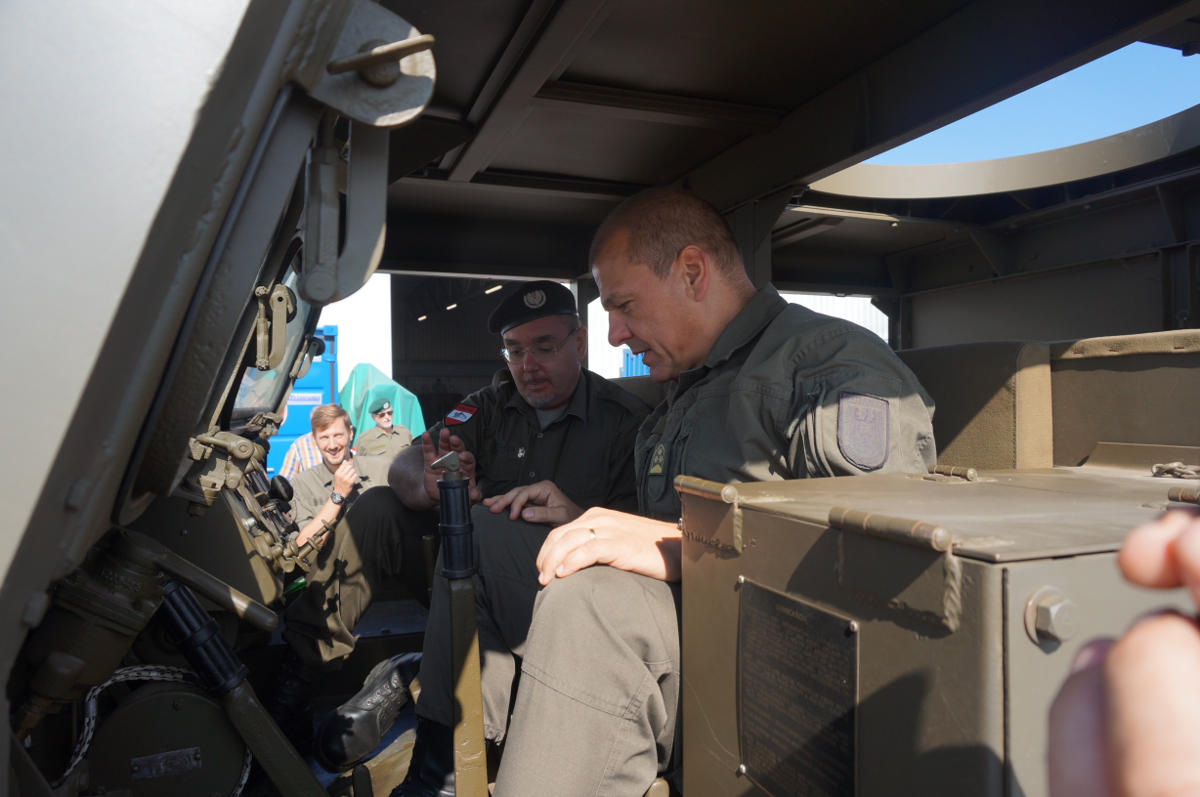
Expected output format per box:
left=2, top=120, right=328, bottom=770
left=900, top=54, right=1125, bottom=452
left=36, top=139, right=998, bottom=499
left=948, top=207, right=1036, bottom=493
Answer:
left=403, top=190, right=935, bottom=797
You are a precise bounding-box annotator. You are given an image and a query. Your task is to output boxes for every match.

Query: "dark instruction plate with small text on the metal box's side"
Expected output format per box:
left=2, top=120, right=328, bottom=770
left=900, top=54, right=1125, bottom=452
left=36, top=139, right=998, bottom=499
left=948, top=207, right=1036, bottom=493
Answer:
left=738, top=581, right=858, bottom=797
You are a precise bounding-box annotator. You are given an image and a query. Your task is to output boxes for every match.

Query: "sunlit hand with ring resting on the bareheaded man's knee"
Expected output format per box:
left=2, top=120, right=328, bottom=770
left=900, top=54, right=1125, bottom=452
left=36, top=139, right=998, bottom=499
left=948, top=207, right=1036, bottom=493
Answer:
left=538, top=507, right=682, bottom=586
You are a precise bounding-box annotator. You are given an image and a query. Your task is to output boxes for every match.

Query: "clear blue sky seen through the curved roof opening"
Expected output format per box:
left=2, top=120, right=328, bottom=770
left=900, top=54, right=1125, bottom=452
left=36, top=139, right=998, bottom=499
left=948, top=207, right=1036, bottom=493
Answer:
left=868, top=42, right=1200, bottom=164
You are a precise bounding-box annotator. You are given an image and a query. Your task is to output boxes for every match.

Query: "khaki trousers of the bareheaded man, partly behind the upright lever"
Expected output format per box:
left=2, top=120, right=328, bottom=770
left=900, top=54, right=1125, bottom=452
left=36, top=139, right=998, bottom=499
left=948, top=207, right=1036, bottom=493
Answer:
left=418, top=507, right=679, bottom=797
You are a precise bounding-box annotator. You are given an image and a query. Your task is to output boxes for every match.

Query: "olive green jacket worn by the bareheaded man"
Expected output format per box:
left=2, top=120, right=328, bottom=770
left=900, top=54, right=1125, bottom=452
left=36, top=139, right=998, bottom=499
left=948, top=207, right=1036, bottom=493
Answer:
left=636, top=286, right=936, bottom=520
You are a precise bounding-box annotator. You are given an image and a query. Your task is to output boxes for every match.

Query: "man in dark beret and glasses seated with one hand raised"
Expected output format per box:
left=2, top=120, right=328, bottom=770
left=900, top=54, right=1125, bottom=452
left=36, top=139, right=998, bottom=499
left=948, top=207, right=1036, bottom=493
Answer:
left=304, top=281, right=649, bottom=777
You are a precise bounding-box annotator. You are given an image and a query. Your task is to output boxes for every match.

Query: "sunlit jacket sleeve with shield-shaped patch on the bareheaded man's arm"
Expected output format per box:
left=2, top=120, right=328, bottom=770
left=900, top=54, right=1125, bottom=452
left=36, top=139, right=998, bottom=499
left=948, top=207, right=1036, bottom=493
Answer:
left=788, top=328, right=936, bottom=477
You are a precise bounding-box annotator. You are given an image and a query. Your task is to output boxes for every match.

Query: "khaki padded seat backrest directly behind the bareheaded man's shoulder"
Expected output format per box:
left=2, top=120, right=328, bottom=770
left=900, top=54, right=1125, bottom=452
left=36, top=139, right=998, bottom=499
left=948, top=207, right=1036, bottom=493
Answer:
left=898, top=341, right=1054, bottom=469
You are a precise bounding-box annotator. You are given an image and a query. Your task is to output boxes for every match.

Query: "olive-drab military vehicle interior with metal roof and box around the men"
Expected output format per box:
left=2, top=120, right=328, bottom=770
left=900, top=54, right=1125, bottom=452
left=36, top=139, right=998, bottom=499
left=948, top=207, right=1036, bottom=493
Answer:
left=0, top=0, right=1200, bottom=797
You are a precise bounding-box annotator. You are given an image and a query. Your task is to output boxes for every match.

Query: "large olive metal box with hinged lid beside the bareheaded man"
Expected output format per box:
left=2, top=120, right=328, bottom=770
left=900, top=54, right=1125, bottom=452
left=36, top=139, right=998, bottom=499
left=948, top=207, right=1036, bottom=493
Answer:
left=676, top=467, right=1186, bottom=797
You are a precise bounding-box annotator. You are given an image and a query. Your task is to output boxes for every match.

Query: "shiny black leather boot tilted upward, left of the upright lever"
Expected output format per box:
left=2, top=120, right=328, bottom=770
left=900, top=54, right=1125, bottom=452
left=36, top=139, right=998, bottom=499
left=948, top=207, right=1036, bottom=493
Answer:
left=313, top=653, right=421, bottom=772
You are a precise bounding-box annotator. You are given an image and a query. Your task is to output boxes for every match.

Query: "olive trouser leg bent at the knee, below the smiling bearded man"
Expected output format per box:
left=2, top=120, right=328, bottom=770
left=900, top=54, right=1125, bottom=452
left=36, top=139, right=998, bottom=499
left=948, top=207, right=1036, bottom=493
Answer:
left=283, top=486, right=437, bottom=669
